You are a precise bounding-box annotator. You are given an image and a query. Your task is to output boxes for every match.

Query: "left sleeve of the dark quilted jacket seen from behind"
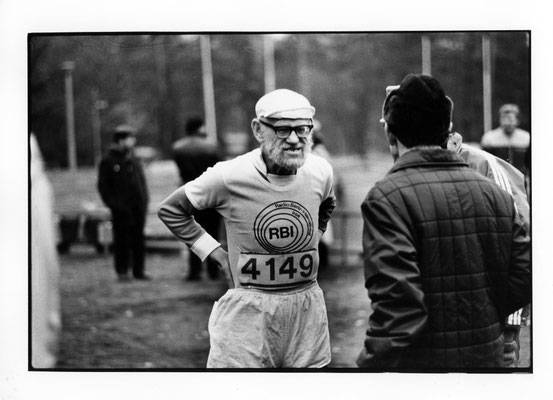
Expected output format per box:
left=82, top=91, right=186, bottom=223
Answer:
left=357, top=194, right=428, bottom=369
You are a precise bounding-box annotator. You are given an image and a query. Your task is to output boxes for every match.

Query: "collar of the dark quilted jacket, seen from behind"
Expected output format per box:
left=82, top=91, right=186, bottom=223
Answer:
left=389, top=148, right=468, bottom=173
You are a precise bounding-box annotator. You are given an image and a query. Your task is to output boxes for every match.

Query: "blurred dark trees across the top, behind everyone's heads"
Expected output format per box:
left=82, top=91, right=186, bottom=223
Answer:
left=29, top=32, right=530, bottom=168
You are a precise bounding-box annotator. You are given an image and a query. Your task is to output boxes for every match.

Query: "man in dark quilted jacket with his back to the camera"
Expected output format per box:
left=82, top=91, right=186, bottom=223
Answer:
left=357, top=74, right=531, bottom=370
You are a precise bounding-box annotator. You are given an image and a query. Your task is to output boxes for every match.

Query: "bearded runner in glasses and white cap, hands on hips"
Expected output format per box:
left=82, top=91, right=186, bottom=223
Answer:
left=159, top=89, right=335, bottom=368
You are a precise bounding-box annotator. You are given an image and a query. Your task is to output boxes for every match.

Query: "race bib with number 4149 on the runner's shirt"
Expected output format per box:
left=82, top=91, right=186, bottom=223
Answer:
left=237, top=249, right=319, bottom=290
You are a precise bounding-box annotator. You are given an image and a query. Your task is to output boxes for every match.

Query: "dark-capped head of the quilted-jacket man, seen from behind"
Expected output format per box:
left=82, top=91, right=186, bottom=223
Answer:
left=384, top=74, right=453, bottom=147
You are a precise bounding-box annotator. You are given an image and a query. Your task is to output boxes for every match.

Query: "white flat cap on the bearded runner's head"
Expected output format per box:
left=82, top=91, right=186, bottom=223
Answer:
left=255, top=89, right=315, bottom=119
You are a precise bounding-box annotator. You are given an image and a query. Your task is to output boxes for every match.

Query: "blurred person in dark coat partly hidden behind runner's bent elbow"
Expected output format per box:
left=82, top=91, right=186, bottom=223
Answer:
left=173, top=117, right=223, bottom=281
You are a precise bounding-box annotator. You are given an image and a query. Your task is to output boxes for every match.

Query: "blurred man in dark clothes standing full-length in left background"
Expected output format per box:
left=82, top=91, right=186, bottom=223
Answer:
left=98, top=125, right=149, bottom=281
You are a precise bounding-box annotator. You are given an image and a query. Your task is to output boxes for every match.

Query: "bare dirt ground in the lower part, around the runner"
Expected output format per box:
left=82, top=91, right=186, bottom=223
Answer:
left=57, top=246, right=530, bottom=370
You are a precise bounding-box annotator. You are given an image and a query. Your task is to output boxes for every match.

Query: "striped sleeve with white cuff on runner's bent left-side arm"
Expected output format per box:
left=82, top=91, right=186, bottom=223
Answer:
left=158, top=186, right=220, bottom=261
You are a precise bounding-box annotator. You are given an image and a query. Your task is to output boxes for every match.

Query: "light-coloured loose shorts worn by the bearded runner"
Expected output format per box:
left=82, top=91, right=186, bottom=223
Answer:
left=207, top=283, right=330, bottom=368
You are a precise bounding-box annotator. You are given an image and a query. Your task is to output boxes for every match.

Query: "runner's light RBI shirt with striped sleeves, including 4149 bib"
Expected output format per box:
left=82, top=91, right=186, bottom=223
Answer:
left=159, top=149, right=336, bottom=290
